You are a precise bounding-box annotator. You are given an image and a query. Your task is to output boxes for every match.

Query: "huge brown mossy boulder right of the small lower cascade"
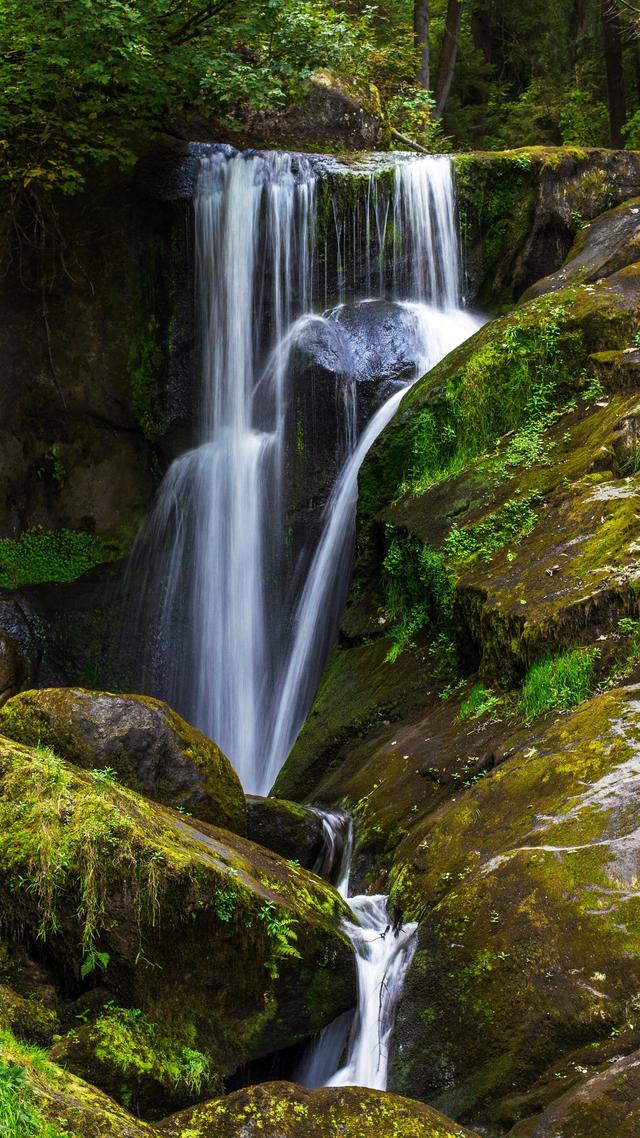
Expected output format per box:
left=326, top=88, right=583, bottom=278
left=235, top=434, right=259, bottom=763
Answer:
left=391, top=685, right=640, bottom=1127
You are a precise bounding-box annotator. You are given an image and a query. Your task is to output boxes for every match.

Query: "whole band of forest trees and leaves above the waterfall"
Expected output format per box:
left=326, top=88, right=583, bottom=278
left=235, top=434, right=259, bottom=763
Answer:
left=0, top=0, right=640, bottom=199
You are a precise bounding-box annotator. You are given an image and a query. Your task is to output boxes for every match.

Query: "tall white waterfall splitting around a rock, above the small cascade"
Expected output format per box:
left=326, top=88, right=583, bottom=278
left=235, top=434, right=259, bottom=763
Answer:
left=133, top=147, right=478, bottom=793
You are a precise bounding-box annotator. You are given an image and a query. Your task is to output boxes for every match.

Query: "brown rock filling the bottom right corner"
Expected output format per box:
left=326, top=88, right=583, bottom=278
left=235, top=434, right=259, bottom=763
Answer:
left=508, top=1050, right=640, bottom=1138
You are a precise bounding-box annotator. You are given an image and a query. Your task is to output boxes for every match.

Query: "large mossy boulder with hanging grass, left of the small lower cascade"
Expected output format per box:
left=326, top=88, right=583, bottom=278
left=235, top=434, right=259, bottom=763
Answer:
left=0, top=739, right=354, bottom=1116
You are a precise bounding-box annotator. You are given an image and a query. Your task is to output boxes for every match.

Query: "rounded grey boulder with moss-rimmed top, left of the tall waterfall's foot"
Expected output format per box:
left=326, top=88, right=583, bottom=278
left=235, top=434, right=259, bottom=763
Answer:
left=0, top=687, right=246, bottom=833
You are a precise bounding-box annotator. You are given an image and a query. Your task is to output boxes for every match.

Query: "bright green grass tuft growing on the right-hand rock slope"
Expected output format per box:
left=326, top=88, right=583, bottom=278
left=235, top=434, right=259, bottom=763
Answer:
left=518, top=648, right=598, bottom=720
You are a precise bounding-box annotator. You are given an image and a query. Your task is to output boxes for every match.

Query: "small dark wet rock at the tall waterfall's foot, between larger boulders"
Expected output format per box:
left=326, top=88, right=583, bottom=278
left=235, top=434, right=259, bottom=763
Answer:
left=247, top=794, right=323, bottom=873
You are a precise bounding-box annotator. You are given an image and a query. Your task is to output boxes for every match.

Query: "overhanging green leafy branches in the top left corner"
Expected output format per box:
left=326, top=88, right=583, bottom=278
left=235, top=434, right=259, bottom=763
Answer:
left=0, top=0, right=369, bottom=203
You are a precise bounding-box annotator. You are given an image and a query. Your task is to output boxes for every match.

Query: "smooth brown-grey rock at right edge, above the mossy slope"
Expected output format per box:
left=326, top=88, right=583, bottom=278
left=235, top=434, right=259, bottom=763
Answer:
left=524, top=198, right=640, bottom=300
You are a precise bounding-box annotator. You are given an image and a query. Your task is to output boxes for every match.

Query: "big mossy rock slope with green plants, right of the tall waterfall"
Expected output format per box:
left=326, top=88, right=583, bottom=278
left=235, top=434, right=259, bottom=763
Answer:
left=276, top=267, right=640, bottom=810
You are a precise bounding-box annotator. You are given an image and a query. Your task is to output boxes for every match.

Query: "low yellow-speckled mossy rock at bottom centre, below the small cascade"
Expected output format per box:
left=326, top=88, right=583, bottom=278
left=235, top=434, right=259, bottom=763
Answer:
left=157, top=1082, right=474, bottom=1138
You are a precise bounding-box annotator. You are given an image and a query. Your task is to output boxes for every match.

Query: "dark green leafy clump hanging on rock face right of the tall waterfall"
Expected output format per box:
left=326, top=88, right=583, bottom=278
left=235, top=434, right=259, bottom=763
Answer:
left=383, top=526, right=453, bottom=662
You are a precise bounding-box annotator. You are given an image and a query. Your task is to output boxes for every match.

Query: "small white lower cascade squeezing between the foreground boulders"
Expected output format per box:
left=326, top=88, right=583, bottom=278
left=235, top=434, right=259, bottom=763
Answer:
left=296, top=809, right=418, bottom=1090
